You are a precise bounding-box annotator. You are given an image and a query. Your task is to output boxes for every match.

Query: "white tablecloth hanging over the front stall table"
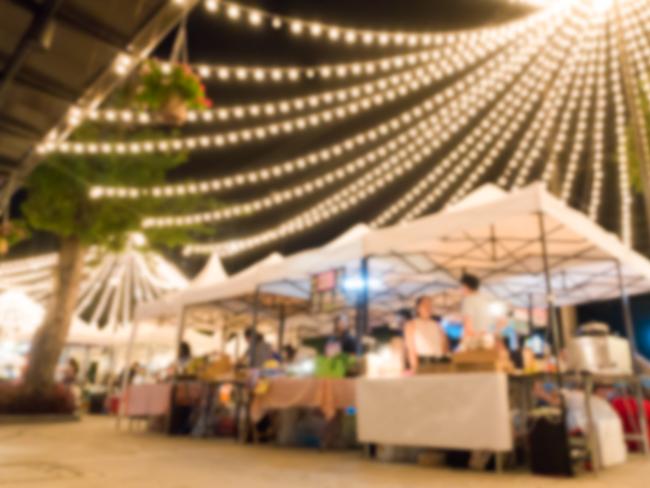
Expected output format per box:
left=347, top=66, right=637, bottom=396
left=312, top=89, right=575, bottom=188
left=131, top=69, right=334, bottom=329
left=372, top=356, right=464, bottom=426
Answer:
left=357, top=373, right=512, bottom=452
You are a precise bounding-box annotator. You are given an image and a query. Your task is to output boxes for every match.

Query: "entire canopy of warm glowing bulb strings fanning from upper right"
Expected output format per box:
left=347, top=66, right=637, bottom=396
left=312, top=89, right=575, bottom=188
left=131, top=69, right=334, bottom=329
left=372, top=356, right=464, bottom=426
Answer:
left=41, top=0, right=650, bottom=255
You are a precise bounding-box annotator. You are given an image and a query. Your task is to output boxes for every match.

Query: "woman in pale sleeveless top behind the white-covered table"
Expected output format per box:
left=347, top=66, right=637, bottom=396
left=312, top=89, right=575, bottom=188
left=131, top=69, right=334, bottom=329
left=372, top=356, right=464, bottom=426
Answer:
left=404, top=296, right=449, bottom=372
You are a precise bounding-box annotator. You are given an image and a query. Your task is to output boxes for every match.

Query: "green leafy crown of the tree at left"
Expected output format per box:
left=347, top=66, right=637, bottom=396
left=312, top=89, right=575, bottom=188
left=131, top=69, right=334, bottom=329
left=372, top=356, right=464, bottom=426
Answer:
left=22, top=125, right=215, bottom=250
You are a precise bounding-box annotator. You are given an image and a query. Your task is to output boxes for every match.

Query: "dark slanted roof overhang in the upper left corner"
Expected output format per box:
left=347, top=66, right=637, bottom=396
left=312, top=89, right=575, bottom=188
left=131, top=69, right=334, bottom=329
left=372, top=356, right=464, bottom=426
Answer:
left=0, top=0, right=197, bottom=211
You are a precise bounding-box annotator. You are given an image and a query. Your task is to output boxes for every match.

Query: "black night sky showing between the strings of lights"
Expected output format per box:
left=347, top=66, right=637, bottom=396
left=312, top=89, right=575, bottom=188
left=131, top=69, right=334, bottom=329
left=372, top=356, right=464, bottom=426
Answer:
left=153, top=0, right=527, bottom=270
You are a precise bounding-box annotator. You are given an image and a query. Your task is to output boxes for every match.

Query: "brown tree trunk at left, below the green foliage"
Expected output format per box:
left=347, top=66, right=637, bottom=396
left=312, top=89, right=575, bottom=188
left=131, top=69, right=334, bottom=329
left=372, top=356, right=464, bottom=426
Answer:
left=25, top=238, right=86, bottom=392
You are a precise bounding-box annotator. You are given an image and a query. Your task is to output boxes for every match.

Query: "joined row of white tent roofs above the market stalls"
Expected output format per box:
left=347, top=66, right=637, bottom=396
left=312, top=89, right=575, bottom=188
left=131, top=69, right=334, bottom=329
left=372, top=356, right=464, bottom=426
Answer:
left=134, top=184, right=650, bottom=318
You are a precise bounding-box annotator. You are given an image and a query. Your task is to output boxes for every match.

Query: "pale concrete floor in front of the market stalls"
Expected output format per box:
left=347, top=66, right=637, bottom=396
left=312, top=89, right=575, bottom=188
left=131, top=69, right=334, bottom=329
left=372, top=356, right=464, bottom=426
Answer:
left=0, top=418, right=650, bottom=488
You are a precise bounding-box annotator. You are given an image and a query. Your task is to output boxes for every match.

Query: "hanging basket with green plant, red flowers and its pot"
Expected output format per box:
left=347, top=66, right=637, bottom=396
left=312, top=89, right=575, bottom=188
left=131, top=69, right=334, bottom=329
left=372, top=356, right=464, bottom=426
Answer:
left=136, top=60, right=212, bottom=125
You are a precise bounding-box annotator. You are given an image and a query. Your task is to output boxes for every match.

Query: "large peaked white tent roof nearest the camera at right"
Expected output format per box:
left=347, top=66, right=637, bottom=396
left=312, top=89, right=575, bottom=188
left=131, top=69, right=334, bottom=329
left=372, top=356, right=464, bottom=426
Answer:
left=365, top=184, right=650, bottom=305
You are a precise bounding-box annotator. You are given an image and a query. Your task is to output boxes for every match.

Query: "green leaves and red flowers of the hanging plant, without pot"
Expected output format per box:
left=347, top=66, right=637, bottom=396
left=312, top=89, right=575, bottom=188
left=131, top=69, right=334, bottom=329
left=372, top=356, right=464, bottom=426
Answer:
left=135, top=60, right=212, bottom=110
